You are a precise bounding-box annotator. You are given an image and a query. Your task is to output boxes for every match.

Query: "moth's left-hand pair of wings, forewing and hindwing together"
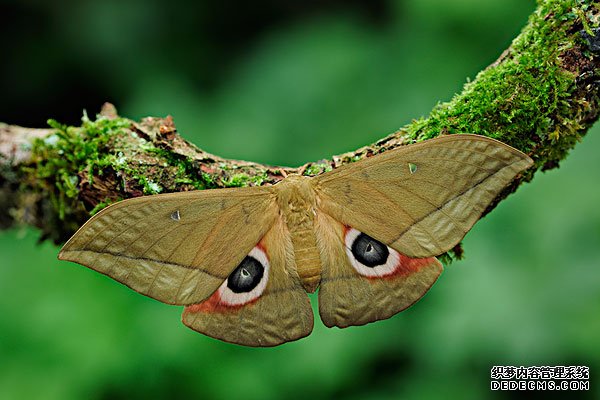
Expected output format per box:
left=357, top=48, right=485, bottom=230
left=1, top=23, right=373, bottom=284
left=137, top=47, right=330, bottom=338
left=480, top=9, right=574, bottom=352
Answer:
left=59, top=187, right=313, bottom=346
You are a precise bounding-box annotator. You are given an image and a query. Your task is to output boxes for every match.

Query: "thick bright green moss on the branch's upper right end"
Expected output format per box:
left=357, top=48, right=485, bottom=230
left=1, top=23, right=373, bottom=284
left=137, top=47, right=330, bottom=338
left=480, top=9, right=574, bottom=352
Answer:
left=405, top=0, right=587, bottom=163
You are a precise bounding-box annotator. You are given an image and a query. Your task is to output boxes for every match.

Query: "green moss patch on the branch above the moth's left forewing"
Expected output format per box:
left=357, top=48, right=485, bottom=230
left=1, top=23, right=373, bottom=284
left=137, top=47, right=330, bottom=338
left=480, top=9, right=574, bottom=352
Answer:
left=27, top=113, right=224, bottom=220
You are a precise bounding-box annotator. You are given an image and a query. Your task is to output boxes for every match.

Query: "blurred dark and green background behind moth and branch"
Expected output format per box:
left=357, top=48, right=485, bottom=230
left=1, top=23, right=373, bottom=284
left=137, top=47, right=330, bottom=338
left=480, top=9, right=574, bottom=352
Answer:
left=0, top=0, right=600, bottom=399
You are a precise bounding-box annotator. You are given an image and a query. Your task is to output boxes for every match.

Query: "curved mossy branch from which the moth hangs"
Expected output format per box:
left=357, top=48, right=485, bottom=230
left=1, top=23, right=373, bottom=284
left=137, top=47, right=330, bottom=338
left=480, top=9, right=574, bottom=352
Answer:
left=0, top=0, right=600, bottom=260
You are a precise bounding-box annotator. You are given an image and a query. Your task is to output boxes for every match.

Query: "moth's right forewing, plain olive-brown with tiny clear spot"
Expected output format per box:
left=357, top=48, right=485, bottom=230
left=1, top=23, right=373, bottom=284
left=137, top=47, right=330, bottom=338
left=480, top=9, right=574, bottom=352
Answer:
left=314, top=134, right=532, bottom=258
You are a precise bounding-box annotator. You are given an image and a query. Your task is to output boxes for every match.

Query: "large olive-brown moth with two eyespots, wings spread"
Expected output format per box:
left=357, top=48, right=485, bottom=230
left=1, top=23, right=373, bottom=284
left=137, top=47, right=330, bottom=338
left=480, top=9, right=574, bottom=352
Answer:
left=59, top=134, right=532, bottom=346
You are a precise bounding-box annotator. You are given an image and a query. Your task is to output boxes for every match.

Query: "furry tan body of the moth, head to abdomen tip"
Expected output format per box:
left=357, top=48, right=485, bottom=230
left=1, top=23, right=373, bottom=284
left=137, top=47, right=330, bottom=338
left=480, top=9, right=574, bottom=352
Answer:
left=275, top=175, right=321, bottom=293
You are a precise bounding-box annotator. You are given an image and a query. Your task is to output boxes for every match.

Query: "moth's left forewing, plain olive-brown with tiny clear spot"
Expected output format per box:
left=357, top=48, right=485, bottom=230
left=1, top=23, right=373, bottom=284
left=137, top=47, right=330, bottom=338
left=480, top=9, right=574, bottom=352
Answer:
left=58, top=187, right=279, bottom=305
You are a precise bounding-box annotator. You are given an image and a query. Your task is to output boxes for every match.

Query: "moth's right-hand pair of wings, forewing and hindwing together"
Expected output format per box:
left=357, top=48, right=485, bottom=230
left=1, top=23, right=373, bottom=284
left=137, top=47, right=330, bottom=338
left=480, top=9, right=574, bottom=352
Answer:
left=314, top=135, right=532, bottom=327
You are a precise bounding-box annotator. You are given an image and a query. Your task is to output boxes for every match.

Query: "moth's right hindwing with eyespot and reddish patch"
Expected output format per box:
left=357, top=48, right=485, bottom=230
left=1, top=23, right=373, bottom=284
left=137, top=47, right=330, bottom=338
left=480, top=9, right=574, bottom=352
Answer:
left=315, top=213, right=442, bottom=328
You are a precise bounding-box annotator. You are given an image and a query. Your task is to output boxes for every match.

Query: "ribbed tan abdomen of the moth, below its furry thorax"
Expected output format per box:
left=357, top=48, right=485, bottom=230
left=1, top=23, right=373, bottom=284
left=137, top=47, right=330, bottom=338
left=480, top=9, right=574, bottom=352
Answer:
left=290, top=227, right=321, bottom=293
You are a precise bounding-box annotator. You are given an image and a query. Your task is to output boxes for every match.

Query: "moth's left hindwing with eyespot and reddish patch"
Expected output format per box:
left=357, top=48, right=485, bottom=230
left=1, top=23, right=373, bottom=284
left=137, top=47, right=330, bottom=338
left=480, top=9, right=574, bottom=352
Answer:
left=182, top=219, right=313, bottom=346
